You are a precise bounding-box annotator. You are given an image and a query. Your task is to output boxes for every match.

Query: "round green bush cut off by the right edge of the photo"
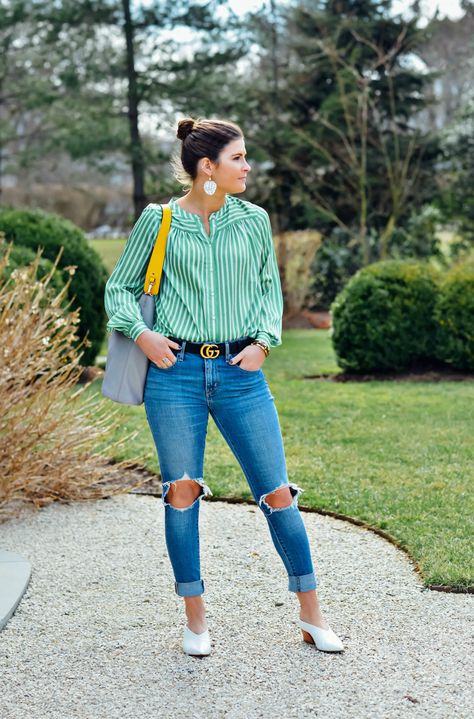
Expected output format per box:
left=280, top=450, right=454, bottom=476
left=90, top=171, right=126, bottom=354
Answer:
left=434, top=256, right=474, bottom=370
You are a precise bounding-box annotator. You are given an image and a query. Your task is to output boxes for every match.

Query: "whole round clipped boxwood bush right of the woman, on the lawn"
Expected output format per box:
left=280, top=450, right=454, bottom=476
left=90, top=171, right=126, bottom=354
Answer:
left=331, top=260, right=439, bottom=373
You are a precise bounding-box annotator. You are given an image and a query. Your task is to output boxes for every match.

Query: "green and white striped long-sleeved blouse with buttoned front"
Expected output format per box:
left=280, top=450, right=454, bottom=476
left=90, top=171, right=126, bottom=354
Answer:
left=104, top=195, right=283, bottom=347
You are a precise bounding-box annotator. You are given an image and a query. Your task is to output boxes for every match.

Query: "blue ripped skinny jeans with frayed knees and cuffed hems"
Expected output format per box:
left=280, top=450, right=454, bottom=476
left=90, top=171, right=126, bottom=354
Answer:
left=144, top=338, right=318, bottom=597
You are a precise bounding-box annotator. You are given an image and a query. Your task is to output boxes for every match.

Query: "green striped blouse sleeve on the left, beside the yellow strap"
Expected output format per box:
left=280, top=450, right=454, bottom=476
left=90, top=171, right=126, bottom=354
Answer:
left=104, top=204, right=162, bottom=341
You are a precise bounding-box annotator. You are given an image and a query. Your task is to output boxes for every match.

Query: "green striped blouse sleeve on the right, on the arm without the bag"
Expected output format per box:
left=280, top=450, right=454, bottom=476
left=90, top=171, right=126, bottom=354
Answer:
left=256, top=211, right=283, bottom=347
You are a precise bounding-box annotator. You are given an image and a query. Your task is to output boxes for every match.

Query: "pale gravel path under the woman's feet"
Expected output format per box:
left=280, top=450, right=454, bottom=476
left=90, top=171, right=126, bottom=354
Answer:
left=0, top=494, right=473, bottom=719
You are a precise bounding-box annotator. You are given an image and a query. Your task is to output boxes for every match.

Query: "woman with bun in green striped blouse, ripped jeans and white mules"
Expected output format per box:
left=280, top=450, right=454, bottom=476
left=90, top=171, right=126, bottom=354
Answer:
left=105, top=118, right=343, bottom=655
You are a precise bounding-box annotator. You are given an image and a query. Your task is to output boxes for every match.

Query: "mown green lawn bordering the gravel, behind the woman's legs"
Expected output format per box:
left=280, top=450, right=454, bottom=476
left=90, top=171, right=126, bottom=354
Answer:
left=83, top=330, right=474, bottom=587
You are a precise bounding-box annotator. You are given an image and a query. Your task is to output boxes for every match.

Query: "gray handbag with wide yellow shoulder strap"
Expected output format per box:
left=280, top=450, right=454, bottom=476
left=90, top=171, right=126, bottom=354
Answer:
left=102, top=205, right=171, bottom=405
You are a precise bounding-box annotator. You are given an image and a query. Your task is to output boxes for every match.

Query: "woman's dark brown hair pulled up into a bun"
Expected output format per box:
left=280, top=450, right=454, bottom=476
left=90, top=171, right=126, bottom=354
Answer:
left=173, top=117, right=244, bottom=187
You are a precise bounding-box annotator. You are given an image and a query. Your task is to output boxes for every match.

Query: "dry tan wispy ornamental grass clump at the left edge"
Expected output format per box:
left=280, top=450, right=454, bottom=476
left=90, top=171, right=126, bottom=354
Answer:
left=0, top=236, right=150, bottom=521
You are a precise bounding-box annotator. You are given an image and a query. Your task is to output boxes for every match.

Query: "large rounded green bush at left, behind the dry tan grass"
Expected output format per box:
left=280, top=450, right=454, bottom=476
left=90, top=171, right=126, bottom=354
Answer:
left=0, top=207, right=108, bottom=365
